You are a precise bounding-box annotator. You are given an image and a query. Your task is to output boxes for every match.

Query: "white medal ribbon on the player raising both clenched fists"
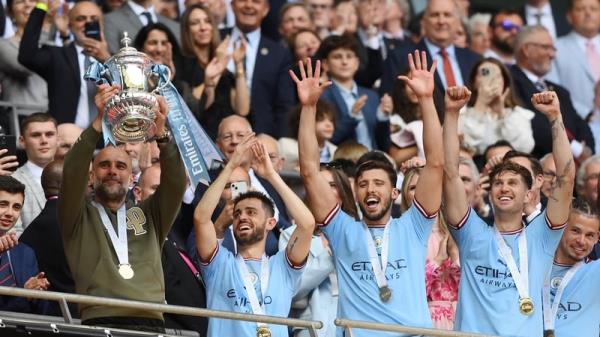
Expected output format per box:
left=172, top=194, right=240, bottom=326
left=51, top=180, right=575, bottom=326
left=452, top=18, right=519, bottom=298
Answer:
left=494, top=226, right=529, bottom=298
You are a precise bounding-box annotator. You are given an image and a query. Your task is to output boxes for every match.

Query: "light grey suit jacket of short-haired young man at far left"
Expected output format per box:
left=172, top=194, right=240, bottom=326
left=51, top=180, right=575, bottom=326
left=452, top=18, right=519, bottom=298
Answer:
left=12, top=165, right=46, bottom=236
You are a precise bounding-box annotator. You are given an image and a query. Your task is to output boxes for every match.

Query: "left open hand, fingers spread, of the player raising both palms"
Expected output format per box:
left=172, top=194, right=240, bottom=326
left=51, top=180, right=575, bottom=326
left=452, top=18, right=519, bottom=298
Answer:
left=289, top=59, right=331, bottom=106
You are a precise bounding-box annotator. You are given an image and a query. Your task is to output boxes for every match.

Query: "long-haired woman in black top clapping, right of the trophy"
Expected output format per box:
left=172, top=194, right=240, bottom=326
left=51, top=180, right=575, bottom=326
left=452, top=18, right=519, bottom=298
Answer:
left=178, top=5, right=250, bottom=139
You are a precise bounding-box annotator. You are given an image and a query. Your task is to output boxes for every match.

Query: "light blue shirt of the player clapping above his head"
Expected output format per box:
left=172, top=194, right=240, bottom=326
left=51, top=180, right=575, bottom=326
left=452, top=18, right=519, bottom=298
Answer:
left=200, top=245, right=302, bottom=337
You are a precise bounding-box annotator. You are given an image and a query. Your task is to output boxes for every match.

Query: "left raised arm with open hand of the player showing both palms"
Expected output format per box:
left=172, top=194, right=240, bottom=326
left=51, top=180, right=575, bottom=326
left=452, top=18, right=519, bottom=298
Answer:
left=290, top=60, right=338, bottom=222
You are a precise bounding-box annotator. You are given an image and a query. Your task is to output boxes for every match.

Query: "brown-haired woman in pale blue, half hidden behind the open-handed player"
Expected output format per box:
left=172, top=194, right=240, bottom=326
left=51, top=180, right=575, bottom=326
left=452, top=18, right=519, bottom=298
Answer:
left=279, top=162, right=358, bottom=337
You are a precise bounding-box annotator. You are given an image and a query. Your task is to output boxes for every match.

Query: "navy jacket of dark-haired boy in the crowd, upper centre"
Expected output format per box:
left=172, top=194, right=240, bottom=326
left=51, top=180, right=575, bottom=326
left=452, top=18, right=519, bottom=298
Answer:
left=321, top=84, right=390, bottom=151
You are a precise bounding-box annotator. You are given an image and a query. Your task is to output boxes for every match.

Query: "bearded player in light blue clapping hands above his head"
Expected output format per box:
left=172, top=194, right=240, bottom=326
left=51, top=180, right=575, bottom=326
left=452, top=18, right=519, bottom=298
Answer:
left=194, top=133, right=315, bottom=337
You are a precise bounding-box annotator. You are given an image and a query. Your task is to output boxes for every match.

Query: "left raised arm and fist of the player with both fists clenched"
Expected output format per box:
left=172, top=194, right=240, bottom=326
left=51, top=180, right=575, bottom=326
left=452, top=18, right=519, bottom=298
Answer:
left=443, top=87, right=471, bottom=225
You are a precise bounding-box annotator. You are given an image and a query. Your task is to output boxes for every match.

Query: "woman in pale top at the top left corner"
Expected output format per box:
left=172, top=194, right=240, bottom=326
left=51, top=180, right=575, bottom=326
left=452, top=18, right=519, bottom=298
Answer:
left=0, top=0, right=52, bottom=117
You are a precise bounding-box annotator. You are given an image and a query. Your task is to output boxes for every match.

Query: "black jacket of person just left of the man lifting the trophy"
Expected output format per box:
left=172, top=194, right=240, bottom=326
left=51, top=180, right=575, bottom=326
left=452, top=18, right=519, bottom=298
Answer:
left=19, top=199, right=79, bottom=316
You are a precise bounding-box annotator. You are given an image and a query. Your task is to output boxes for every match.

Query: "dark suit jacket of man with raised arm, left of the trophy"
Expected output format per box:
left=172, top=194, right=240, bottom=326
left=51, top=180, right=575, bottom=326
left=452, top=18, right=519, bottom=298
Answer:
left=19, top=8, right=81, bottom=124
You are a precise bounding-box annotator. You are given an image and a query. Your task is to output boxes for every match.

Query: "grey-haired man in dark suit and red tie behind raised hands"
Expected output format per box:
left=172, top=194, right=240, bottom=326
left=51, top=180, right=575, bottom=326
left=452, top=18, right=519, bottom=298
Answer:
left=380, top=0, right=481, bottom=118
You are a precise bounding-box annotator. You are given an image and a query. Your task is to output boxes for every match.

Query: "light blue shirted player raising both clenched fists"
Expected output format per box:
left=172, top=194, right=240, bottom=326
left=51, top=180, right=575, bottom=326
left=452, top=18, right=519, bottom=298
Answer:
left=444, top=87, right=575, bottom=337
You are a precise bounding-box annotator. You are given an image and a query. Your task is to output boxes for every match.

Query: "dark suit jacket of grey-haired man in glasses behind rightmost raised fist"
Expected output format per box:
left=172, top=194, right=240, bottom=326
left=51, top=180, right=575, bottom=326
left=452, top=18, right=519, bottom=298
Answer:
left=510, top=65, right=595, bottom=157
